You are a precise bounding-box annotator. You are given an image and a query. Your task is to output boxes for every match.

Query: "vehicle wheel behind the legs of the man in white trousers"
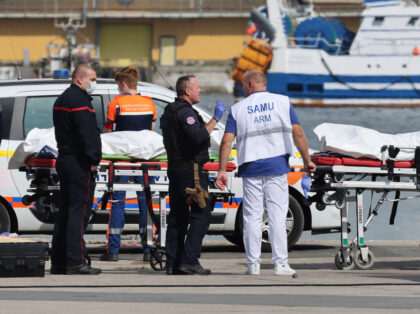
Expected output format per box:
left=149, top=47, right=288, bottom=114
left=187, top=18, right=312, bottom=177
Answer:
left=225, top=195, right=305, bottom=251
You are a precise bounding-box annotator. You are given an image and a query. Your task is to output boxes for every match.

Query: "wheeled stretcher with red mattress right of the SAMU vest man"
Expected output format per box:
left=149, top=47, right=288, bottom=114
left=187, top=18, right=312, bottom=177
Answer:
left=309, top=146, right=420, bottom=269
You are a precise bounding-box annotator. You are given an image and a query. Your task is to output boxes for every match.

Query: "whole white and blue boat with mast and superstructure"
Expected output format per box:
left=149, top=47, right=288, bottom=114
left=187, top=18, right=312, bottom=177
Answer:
left=267, top=0, right=420, bottom=107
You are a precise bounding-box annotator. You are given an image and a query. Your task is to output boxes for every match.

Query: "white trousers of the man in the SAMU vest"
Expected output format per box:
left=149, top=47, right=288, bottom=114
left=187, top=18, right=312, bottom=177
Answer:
left=243, top=174, right=289, bottom=265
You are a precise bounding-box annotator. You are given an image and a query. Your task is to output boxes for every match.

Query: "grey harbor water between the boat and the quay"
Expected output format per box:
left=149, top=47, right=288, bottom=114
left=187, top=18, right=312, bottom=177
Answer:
left=199, top=94, right=420, bottom=240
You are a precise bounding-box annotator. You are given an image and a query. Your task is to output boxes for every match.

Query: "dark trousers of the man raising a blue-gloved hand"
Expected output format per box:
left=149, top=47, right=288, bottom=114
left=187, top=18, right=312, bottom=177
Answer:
left=166, top=168, right=210, bottom=268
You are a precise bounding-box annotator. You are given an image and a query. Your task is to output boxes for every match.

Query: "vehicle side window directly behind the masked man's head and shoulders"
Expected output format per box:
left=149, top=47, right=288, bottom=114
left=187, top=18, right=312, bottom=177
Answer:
left=23, top=95, right=104, bottom=137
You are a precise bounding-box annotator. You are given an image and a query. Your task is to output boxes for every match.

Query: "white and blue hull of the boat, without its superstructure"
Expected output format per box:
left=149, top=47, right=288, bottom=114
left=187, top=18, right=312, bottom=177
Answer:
left=267, top=49, right=420, bottom=107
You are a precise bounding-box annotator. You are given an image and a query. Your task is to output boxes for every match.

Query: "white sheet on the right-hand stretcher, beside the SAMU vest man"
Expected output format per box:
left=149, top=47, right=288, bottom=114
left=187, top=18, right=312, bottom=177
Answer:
left=314, top=123, right=420, bottom=160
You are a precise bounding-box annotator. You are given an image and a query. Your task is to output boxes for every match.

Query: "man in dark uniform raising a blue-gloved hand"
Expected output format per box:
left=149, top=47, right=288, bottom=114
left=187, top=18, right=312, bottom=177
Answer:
left=160, top=75, right=226, bottom=275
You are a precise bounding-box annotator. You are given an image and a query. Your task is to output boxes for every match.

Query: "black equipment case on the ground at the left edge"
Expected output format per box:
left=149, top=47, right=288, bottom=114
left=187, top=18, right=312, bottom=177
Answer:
left=0, top=242, right=48, bottom=277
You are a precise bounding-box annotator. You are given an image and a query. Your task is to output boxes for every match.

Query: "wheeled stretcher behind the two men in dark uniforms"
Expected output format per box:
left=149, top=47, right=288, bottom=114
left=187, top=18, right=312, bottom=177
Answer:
left=21, top=157, right=236, bottom=270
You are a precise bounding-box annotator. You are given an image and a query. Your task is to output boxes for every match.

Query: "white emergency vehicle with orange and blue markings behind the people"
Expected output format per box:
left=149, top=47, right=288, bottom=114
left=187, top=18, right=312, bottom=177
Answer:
left=0, top=78, right=340, bottom=246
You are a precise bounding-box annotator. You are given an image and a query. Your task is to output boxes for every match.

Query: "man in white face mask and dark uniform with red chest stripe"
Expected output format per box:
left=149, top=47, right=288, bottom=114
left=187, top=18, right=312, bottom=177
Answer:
left=51, top=65, right=102, bottom=275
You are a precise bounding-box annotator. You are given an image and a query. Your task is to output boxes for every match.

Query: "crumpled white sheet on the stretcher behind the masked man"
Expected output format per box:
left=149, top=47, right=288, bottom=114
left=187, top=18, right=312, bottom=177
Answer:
left=9, top=128, right=165, bottom=169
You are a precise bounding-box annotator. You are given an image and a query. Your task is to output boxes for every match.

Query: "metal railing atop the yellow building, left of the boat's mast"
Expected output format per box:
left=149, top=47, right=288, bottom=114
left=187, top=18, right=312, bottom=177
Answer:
left=0, top=0, right=266, bottom=16
